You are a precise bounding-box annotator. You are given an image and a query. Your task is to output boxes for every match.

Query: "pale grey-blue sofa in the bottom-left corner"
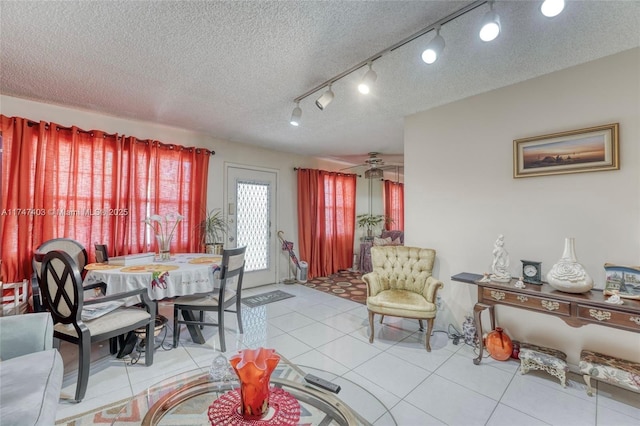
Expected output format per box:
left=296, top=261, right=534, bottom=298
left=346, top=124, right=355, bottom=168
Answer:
left=0, top=312, right=64, bottom=426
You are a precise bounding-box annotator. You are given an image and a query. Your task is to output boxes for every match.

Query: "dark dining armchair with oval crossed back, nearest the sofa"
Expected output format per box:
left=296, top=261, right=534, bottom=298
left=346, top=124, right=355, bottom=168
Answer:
left=41, top=250, right=156, bottom=402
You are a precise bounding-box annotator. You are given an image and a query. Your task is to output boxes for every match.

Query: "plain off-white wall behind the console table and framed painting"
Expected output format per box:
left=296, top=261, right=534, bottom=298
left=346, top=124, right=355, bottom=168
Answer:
left=405, top=48, right=640, bottom=364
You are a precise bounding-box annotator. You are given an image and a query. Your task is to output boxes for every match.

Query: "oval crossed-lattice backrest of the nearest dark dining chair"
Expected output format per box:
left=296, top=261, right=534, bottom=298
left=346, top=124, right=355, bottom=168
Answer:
left=40, top=250, right=84, bottom=324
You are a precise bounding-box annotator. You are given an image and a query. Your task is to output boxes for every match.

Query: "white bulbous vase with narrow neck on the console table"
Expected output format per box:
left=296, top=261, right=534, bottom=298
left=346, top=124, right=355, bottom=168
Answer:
left=547, top=238, right=593, bottom=293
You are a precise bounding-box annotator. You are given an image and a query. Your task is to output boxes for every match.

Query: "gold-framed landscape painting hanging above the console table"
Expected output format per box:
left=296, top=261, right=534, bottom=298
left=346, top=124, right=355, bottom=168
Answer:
left=513, top=123, right=620, bottom=178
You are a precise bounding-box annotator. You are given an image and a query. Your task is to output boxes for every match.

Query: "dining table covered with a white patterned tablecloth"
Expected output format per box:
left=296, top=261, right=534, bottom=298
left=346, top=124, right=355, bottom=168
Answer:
left=83, top=253, right=222, bottom=344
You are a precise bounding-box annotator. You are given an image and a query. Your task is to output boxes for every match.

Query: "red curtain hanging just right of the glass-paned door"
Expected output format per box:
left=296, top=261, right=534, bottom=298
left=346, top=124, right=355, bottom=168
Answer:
left=298, top=169, right=357, bottom=278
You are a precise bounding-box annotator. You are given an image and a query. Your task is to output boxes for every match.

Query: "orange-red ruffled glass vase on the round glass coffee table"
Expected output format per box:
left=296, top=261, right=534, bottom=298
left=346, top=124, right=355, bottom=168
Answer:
left=229, top=348, right=280, bottom=420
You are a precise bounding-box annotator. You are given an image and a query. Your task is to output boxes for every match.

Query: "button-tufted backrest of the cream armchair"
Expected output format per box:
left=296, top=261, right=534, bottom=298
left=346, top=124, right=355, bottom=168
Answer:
left=371, top=246, right=436, bottom=293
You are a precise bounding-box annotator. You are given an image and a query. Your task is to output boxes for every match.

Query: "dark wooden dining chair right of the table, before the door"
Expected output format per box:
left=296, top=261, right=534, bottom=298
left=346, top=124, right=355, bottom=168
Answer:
left=173, top=247, right=246, bottom=352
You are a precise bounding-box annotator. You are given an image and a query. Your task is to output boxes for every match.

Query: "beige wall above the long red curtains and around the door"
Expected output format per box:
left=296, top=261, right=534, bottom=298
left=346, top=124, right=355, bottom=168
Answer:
left=0, top=95, right=318, bottom=280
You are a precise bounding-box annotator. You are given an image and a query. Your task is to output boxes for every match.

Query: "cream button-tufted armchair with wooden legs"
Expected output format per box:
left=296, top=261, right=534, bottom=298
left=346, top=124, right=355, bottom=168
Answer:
left=362, top=246, right=443, bottom=352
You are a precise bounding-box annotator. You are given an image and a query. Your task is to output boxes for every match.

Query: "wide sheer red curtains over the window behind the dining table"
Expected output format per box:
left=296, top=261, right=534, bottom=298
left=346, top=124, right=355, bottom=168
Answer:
left=0, top=115, right=210, bottom=282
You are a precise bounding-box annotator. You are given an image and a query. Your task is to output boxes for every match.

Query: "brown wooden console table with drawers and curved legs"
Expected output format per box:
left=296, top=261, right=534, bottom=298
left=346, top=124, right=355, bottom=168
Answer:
left=451, top=272, right=640, bottom=365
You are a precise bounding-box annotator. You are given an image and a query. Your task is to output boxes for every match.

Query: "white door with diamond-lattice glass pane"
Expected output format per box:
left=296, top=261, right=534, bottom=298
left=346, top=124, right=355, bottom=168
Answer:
left=226, top=165, right=277, bottom=288
